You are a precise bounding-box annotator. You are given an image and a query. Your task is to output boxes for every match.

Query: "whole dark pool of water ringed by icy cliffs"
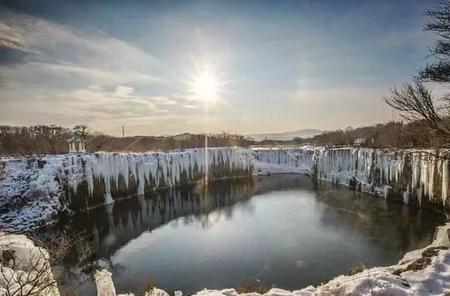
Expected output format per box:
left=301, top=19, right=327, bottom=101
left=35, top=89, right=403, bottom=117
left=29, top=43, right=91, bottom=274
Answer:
left=51, top=175, right=444, bottom=295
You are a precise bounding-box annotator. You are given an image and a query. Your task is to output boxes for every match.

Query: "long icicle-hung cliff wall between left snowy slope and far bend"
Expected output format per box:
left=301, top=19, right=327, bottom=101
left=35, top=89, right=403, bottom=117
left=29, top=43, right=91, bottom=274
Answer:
left=66, top=148, right=253, bottom=208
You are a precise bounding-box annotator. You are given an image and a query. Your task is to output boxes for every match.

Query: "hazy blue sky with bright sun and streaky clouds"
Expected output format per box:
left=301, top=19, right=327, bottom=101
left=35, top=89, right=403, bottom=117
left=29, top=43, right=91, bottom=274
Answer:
left=0, top=0, right=438, bottom=135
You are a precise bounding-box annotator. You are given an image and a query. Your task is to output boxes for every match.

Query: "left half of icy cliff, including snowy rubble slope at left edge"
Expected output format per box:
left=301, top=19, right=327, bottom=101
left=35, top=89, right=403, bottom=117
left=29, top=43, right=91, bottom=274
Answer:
left=0, top=147, right=254, bottom=231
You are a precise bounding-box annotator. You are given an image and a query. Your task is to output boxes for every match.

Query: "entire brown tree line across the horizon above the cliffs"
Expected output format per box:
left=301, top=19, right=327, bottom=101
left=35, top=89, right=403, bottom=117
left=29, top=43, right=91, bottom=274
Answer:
left=0, top=120, right=450, bottom=156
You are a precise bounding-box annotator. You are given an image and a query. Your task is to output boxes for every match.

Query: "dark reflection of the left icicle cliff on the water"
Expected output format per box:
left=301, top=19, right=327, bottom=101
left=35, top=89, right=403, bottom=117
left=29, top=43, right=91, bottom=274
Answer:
left=70, top=175, right=314, bottom=258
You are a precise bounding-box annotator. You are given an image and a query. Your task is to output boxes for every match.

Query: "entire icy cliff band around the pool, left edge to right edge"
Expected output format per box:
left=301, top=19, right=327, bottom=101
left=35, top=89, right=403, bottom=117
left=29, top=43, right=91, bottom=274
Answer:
left=0, top=147, right=449, bottom=231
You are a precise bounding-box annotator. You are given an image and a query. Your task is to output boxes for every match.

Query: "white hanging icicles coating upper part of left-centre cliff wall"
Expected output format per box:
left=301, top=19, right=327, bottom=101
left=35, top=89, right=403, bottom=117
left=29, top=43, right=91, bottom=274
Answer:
left=69, top=148, right=252, bottom=204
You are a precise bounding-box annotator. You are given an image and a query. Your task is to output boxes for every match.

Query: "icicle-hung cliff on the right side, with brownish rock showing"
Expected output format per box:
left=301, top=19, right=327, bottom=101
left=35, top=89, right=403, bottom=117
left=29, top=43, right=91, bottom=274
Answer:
left=256, top=147, right=449, bottom=208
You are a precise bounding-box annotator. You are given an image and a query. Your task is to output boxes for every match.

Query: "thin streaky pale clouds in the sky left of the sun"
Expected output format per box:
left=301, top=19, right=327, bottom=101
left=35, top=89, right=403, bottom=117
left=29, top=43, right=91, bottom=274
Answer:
left=0, top=11, right=185, bottom=130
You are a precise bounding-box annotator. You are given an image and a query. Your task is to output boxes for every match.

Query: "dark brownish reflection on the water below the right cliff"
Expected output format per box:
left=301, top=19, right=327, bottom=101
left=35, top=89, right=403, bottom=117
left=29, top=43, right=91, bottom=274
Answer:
left=317, top=185, right=436, bottom=262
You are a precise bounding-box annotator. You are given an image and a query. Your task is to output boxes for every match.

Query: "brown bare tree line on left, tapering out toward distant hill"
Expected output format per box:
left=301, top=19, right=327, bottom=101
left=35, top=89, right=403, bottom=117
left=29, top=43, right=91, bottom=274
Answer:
left=0, top=125, right=254, bottom=156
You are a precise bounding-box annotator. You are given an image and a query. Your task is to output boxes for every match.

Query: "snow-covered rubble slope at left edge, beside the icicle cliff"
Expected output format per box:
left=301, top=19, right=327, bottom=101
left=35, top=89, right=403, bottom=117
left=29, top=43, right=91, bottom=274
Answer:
left=0, top=156, right=68, bottom=231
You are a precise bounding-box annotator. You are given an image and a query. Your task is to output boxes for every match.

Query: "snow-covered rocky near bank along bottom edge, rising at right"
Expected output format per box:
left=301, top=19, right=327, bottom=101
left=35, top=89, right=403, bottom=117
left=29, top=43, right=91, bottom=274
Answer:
left=96, top=223, right=450, bottom=296
